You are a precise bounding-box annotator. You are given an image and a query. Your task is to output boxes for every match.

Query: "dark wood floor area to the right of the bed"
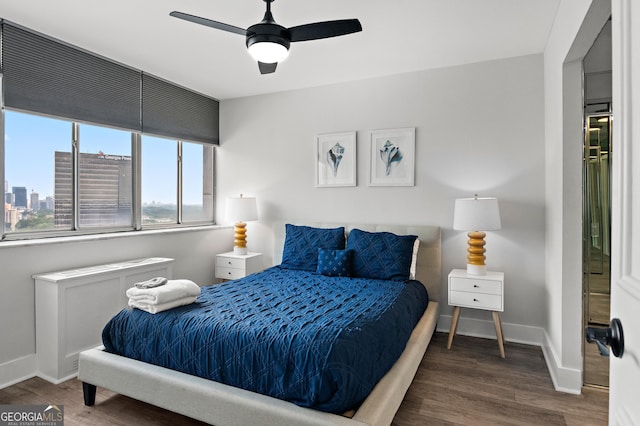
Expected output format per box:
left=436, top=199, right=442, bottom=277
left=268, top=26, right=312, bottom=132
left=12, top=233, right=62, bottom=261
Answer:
left=394, top=333, right=609, bottom=426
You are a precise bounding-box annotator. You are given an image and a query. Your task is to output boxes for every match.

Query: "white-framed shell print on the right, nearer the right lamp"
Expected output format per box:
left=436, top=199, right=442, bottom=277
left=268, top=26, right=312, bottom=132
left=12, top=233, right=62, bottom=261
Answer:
left=369, top=127, right=416, bottom=186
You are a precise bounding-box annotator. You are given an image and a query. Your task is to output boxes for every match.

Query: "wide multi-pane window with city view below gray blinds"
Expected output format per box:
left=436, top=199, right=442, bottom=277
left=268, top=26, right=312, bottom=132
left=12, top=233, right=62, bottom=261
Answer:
left=4, top=110, right=214, bottom=238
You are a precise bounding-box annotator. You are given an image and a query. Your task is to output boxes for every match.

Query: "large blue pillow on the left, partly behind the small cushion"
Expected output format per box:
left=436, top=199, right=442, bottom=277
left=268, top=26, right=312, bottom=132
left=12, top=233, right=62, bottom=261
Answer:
left=280, top=223, right=345, bottom=272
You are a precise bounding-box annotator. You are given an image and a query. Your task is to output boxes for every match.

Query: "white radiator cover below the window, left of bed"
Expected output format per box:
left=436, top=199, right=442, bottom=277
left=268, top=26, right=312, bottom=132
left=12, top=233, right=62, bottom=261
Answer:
left=33, top=257, right=173, bottom=384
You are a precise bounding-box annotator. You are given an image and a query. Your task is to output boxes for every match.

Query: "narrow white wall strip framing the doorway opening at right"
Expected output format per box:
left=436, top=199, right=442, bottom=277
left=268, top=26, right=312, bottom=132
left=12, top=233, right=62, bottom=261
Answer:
left=543, top=0, right=611, bottom=393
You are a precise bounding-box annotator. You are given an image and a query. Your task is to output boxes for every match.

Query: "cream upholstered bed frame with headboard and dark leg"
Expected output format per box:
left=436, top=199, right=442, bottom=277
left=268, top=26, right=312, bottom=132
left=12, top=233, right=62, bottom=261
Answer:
left=78, top=222, right=441, bottom=426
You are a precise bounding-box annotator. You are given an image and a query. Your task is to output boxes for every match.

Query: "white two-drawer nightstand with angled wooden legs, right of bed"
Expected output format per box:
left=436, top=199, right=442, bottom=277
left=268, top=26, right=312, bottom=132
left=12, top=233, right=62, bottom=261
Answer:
left=447, top=269, right=505, bottom=358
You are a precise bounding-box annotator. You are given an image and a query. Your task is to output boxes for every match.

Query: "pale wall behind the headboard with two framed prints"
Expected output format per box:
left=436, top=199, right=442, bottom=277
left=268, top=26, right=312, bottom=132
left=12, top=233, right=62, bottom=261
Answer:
left=217, top=55, right=548, bottom=344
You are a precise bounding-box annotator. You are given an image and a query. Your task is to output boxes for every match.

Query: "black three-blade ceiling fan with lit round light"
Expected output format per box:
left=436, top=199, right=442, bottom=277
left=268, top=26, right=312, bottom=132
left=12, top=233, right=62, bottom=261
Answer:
left=169, top=0, right=362, bottom=74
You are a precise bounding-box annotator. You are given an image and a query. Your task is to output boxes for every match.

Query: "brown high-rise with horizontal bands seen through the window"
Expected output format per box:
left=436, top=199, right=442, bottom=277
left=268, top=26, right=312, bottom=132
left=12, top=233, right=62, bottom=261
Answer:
left=54, top=151, right=133, bottom=228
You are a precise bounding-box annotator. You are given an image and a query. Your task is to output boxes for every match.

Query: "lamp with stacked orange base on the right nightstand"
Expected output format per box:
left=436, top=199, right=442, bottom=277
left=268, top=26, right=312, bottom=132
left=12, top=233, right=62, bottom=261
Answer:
left=453, top=194, right=501, bottom=275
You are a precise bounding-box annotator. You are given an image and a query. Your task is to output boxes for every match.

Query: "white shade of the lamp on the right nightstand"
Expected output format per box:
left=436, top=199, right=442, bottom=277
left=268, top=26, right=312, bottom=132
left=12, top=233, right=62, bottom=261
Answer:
left=453, top=197, right=501, bottom=231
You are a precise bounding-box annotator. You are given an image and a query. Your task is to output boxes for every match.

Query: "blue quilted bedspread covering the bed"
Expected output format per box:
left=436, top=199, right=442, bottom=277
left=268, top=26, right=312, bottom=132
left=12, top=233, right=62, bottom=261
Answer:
left=102, top=267, right=428, bottom=413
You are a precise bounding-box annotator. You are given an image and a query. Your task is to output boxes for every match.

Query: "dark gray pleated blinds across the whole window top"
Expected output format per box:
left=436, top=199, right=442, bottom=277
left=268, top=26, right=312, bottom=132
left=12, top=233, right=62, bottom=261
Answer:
left=0, top=21, right=219, bottom=144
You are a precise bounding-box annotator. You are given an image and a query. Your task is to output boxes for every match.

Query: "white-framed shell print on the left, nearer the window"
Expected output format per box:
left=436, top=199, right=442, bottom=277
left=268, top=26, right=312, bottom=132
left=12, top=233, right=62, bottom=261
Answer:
left=316, top=131, right=357, bottom=188
